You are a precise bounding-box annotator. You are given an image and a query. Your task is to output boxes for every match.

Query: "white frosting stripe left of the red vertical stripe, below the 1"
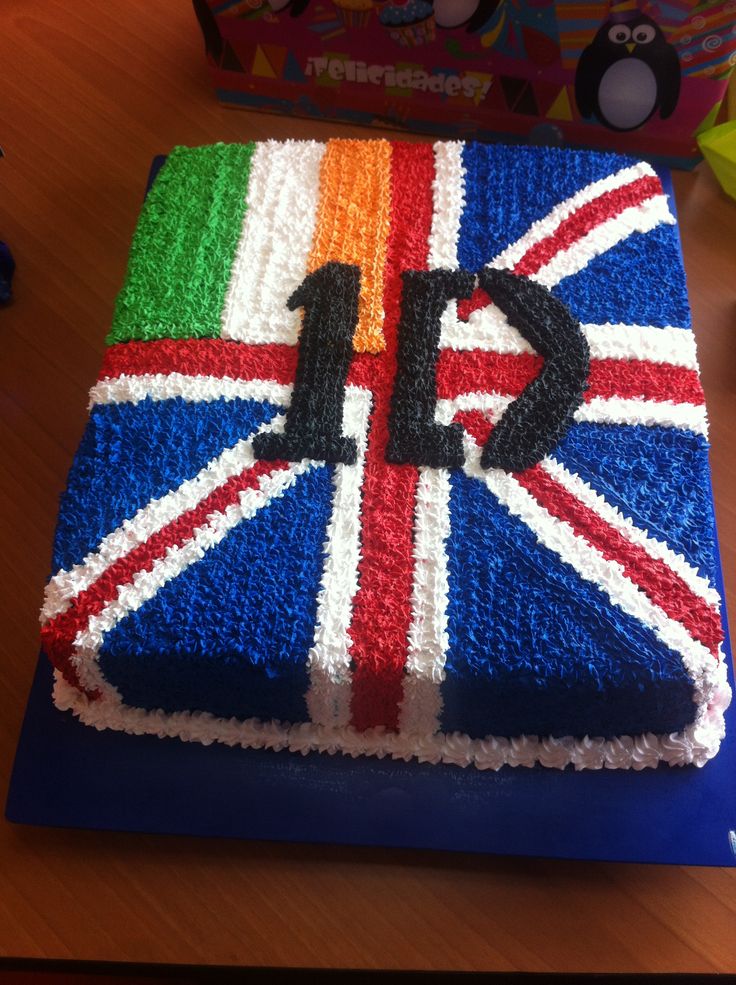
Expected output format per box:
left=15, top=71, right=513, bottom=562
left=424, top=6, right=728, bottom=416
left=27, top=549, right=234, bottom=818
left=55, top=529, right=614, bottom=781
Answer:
left=307, top=386, right=371, bottom=726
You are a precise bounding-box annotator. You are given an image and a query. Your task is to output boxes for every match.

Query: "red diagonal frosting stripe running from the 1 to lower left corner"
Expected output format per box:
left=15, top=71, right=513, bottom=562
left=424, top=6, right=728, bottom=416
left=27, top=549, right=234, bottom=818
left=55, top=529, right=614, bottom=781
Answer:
left=41, top=462, right=288, bottom=686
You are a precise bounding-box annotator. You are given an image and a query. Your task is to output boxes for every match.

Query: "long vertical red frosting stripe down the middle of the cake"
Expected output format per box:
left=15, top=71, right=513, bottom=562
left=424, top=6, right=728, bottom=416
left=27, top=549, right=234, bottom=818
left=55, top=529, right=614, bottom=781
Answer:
left=350, top=143, right=434, bottom=730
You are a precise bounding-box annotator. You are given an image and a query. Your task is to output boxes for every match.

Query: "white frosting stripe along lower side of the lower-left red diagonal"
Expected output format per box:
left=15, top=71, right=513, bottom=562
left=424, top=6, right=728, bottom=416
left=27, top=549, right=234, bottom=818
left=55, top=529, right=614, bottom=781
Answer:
left=71, top=462, right=324, bottom=693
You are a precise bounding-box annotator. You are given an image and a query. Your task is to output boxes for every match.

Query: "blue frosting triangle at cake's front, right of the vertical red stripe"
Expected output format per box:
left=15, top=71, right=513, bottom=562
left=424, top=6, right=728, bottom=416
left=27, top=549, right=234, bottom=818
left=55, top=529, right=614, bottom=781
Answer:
left=441, top=473, right=694, bottom=737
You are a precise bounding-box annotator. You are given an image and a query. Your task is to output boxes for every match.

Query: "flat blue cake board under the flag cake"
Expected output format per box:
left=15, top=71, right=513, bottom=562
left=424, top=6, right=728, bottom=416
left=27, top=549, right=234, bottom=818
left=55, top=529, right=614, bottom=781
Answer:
left=5, top=157, right=736, bottom=866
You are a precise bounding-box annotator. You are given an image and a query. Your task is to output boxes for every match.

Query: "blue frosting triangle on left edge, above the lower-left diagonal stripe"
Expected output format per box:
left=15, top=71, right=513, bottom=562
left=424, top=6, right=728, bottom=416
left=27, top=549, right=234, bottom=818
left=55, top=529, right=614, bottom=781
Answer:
left=53, top=398, right=279, bottom=571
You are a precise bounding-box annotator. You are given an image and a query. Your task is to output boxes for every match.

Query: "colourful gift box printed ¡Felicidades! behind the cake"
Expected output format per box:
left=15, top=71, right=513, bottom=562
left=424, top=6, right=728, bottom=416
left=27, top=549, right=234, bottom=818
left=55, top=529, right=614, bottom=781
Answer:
left=194, top=0, right=736, bottom=167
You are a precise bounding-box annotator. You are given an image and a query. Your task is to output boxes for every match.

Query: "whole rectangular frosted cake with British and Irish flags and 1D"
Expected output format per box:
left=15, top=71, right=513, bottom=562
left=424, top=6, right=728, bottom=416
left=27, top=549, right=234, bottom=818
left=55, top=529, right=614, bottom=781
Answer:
left=41, top=140, right=730, bottom=769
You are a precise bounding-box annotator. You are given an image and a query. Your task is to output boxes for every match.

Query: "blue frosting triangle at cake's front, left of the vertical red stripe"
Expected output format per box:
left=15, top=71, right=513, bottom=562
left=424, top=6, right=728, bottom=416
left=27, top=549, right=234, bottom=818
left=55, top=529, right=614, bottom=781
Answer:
left=95, top=468, right=332, bottom=722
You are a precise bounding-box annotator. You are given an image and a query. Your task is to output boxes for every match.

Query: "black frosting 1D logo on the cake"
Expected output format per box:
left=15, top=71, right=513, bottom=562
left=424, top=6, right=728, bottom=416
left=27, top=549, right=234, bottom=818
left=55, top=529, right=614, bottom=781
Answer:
left=253, top=261, right=590, bottom=472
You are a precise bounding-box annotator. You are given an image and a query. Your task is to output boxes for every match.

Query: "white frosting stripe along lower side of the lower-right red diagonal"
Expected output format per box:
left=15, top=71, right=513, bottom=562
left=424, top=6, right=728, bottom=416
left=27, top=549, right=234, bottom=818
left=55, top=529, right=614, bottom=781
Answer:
left=464, top=438, right=716, bottom=693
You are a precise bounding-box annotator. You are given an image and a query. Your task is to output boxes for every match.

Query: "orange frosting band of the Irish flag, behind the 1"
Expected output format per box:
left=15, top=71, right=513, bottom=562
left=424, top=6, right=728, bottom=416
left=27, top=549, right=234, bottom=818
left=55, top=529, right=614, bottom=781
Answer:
left=308, top=140, right=391, bottom=352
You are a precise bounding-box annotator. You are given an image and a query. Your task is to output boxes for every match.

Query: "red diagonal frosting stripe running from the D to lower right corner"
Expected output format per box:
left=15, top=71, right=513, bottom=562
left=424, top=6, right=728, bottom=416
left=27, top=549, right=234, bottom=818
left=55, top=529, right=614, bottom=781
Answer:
left=516, top=465, right=723, bottom=655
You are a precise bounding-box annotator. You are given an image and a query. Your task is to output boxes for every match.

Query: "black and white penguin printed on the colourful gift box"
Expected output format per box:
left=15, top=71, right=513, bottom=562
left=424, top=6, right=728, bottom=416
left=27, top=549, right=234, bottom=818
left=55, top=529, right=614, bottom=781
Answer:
left=575, top=0, right=680, bottom=131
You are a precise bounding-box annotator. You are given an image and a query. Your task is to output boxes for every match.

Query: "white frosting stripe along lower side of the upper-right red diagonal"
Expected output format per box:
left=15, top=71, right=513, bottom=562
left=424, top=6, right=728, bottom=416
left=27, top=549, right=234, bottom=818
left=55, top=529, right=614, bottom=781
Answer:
left=531, top=195, right=675, bottom=288
